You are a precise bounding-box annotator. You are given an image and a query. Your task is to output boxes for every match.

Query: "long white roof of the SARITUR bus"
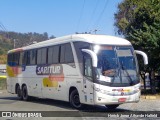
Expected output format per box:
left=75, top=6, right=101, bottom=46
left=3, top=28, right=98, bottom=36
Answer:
left=9, top=34, right=131, bottom=53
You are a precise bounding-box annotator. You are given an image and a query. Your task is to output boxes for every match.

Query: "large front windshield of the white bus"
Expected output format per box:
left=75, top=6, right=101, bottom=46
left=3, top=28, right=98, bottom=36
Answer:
left=96, top=46, right=139, bottom=86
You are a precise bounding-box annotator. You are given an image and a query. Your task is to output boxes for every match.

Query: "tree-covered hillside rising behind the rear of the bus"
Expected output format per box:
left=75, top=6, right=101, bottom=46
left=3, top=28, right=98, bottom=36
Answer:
left=0, top=31, right=55, bottom=64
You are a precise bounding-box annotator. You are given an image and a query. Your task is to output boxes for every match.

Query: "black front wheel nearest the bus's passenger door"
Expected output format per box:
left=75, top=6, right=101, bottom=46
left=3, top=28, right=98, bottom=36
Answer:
left=69, top=89, right=82, bottom=109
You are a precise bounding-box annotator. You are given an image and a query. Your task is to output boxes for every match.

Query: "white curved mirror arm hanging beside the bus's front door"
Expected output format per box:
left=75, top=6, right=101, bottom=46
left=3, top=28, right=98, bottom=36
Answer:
left=82, top=49, right=98, bottom=67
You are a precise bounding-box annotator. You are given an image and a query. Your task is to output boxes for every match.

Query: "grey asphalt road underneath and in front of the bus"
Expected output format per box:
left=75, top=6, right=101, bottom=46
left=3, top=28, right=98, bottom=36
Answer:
left=0, top=90, right=160, bottom=120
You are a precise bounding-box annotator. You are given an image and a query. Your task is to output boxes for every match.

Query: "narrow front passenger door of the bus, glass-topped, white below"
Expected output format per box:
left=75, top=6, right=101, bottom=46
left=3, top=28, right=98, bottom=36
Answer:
left=83, top=53, right=94, bottom=104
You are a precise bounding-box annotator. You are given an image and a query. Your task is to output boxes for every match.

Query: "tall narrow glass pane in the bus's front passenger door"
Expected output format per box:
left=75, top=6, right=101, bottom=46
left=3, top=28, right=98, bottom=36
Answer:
left=84, top=56, right=92, bottom=77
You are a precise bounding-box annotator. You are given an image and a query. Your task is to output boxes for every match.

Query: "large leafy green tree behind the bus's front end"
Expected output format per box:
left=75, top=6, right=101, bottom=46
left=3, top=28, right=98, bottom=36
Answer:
left=115, top=0, right=160, bottom=92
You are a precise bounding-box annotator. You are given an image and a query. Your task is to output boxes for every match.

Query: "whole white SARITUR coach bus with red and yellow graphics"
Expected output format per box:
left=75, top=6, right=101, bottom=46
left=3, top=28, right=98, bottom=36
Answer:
left=7, top=34, right=148, bottom=109
